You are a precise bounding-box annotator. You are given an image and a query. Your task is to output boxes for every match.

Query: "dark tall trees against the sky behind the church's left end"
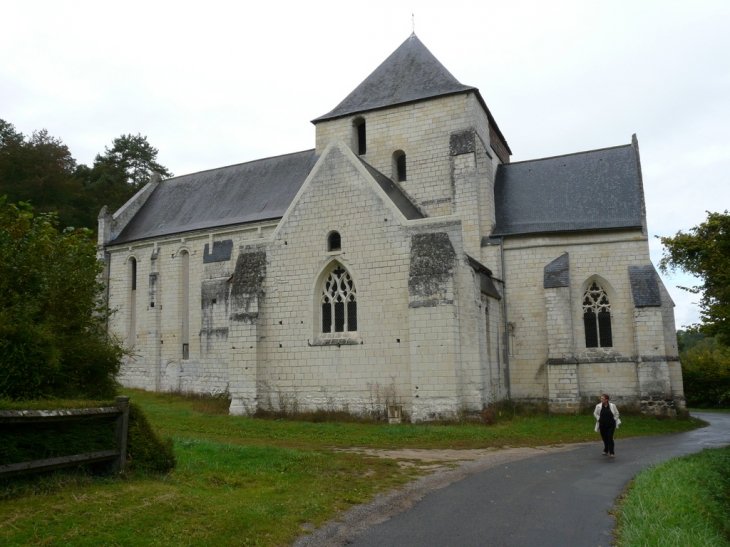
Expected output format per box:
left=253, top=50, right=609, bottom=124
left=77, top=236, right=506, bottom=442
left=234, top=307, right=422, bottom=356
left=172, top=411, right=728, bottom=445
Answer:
left=0, top=119, right=172, bottom=231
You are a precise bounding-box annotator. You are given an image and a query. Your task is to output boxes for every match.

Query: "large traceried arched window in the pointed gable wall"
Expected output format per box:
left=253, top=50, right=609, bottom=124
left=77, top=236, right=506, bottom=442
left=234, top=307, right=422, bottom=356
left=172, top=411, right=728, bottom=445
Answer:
left=321, top=264, right=357, bottom=333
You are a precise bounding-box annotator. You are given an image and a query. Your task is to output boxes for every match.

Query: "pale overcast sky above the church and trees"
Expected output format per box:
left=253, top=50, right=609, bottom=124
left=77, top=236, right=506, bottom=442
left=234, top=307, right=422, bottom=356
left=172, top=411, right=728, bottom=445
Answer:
left=0, top=0, right=730, bottom=327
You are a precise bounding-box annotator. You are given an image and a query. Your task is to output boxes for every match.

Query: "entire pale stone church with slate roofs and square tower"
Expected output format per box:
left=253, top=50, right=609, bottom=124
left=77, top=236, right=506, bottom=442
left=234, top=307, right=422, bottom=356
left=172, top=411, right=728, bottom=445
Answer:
left=99, top=34, right=684, bottom=422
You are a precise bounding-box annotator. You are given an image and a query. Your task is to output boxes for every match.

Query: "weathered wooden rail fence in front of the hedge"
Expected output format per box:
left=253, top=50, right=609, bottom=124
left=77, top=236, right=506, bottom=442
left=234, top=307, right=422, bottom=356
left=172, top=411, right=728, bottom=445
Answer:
left=0, top=396, right=129, bottom=478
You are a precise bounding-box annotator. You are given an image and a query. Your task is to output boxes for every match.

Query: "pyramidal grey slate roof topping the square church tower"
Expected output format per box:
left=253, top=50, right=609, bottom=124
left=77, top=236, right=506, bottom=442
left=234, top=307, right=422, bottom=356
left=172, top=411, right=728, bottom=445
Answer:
left=312, top=34, right=478, bottom=124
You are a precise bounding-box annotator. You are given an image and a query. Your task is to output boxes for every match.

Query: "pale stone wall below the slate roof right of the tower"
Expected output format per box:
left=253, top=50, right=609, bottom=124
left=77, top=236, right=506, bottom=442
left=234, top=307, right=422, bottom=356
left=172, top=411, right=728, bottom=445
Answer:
left=505, top=231, right=681, bottom=411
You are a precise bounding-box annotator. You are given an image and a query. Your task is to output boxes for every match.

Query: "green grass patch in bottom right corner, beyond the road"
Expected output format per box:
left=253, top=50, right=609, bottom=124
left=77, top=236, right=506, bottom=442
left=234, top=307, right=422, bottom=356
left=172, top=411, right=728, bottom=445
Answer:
left=616, top=447, right=730, bottom=547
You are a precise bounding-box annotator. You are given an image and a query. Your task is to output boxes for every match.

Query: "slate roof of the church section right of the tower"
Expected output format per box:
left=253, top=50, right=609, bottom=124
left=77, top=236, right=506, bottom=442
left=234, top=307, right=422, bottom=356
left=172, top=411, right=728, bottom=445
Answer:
left=491, top=145, right=644, bottom=236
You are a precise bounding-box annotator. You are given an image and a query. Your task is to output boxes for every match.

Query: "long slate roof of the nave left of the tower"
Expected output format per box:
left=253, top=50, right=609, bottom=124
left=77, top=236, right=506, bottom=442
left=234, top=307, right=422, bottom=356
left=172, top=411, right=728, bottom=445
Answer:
left=111, top=150, right=317, bottom=245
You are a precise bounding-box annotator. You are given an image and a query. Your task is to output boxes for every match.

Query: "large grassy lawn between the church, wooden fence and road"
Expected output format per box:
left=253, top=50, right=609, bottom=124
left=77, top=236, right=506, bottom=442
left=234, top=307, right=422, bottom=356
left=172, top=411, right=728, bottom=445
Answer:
left=0, top=390, right=698, bottom=546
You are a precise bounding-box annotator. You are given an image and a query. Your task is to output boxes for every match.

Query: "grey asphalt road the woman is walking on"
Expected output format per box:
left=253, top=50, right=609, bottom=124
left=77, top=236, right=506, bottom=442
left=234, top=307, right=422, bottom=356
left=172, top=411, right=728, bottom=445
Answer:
left=308, top=413, right=730, bottom=547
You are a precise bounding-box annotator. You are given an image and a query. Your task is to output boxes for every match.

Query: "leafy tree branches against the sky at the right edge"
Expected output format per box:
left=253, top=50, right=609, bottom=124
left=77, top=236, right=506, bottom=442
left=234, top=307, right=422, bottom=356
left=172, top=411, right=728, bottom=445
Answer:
left=659, top=211, right=730, bottom=345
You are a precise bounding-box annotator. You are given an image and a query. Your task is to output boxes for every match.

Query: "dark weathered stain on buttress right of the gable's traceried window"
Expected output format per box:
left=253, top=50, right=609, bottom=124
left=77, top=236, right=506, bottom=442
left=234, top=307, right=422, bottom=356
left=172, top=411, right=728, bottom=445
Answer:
left=408, top=232, right=456, bottom=300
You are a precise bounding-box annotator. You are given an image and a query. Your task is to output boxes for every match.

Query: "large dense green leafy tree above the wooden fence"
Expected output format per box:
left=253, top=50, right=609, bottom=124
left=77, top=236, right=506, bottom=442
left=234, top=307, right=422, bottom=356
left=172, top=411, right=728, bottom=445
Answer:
left=0, top=196, right=124, bottom=399
